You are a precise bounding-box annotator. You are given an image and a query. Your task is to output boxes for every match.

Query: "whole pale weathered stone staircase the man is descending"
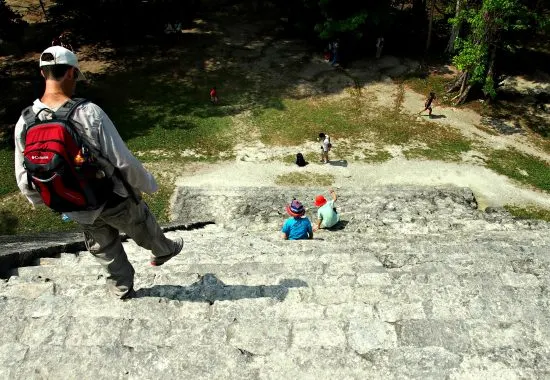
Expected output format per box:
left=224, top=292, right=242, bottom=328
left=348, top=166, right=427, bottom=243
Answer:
left=0, top=187, right=550, bottom=379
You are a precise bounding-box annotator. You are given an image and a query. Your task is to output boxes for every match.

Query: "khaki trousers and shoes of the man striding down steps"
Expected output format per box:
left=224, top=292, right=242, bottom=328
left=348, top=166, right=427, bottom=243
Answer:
left=82, top=198, right=175, bottom=297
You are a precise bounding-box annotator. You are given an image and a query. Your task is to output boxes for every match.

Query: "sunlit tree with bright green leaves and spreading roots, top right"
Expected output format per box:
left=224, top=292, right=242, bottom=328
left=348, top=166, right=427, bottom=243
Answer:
left=448, top=0, right=532, bottom=104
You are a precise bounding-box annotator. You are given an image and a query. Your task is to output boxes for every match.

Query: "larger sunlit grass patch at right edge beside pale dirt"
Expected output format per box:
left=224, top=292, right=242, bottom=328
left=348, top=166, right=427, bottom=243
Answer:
left=487, top=149, right=550, bottom=192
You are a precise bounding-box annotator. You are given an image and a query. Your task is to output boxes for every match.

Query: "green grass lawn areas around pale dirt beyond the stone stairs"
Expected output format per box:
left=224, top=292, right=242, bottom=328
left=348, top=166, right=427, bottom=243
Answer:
left=0, top=45, right=550, bottom=234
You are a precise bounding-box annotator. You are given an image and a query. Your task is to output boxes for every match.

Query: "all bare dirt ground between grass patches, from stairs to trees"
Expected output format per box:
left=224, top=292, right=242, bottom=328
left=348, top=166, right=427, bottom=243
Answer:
left=12, top=16, right=550, bottom=209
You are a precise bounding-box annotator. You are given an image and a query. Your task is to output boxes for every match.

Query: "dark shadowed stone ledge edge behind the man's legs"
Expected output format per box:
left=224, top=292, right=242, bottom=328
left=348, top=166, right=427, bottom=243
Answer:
left=0, top=221, right=214, bottom=278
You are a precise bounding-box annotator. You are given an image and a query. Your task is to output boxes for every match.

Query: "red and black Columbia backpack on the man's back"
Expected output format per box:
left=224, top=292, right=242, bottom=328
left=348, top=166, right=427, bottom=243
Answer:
left=22, top=99, right=113, bottom=212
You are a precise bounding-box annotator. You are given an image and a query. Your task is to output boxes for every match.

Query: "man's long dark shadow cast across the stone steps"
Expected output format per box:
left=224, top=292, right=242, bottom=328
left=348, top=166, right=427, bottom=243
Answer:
left=136, top=273, right=308, bottom=304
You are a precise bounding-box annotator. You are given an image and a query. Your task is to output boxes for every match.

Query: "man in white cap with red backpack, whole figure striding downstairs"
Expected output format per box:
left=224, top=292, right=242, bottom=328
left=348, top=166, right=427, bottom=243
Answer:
left=14, top=46, right=183, bottom=299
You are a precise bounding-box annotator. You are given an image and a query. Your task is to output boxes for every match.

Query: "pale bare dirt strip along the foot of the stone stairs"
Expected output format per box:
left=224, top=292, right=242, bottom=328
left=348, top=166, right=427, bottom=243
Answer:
left=176, top=158, right=550, bottom=209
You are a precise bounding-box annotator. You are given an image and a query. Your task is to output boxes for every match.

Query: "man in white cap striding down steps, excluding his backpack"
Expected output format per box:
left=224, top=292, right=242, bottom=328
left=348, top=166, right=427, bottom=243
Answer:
left=15, top=46, right=183, bottom=299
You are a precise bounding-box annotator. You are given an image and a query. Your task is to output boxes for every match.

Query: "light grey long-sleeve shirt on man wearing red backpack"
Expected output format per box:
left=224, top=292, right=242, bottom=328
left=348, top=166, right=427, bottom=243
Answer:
left=15, top=99, right=158, bottom=224
